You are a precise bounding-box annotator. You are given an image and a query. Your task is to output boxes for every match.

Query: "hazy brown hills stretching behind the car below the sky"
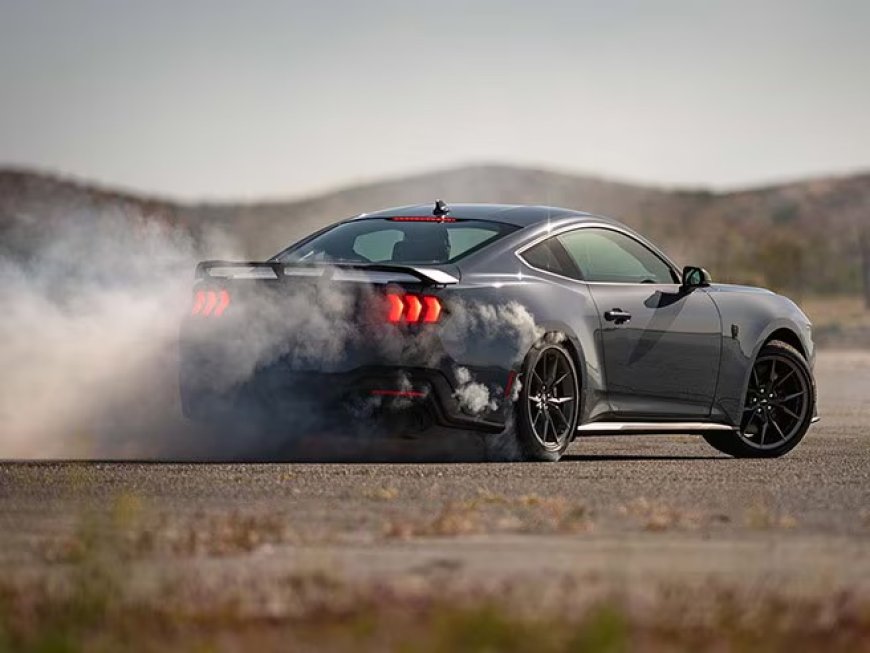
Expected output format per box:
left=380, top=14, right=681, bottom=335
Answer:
left=0, top=165, right=870, bottom=294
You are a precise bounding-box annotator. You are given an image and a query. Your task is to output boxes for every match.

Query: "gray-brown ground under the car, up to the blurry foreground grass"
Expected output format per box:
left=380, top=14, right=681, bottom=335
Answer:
left=0, top=351, right=870, bottom=650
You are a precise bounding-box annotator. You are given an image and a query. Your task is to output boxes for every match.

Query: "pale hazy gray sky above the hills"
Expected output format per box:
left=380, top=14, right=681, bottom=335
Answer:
left=0, top=0, right=870, bottom=199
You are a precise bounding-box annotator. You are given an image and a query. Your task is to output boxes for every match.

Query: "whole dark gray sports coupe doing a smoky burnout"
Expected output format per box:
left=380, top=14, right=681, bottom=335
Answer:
left=180, top=201, right=817, bottom=461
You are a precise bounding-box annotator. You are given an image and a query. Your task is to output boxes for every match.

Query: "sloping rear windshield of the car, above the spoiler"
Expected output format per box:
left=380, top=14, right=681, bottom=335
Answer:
left=275, top=218, right=518, bottom=264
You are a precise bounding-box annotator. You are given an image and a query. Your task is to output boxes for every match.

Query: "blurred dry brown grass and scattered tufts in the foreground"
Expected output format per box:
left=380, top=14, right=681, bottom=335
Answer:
left=0, top=492, right=870, bottom=653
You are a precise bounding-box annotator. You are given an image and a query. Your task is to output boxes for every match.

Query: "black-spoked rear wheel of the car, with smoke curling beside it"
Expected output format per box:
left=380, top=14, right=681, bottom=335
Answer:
left=514, top=341, right=580, bottom=462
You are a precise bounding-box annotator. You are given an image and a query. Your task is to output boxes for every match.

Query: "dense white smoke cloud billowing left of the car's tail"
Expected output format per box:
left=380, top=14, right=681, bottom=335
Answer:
left=0, top=212, right=231, bottom=457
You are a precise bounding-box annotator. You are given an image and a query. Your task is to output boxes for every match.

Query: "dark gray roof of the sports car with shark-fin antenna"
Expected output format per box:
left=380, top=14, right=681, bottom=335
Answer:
left=354, top=202, right=620, bottom=227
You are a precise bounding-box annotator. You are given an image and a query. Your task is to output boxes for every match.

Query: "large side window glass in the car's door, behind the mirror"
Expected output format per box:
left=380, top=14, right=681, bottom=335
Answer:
left=557, top=228, right=677, bottom=284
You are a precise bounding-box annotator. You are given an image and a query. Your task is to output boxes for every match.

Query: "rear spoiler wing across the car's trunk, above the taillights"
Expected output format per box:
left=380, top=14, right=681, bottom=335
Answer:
left=194, top=261, right=459, bottom=286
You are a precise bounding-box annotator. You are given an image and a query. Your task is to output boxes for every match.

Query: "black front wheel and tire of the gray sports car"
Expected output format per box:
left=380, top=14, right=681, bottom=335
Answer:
left=704, top=340, right=816, bottom=458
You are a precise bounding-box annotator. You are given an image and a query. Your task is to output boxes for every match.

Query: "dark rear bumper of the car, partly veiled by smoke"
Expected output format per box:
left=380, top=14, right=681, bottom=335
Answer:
left=180, top=364, right=510, bottom=433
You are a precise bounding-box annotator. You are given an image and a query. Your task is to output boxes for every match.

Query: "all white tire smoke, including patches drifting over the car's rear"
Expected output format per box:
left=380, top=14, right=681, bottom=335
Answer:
left=0, top=210, right=540, bottom=458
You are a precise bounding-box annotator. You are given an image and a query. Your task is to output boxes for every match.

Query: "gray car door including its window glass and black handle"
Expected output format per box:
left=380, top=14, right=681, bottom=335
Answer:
left=556, top=226, right=722, bottom=419
